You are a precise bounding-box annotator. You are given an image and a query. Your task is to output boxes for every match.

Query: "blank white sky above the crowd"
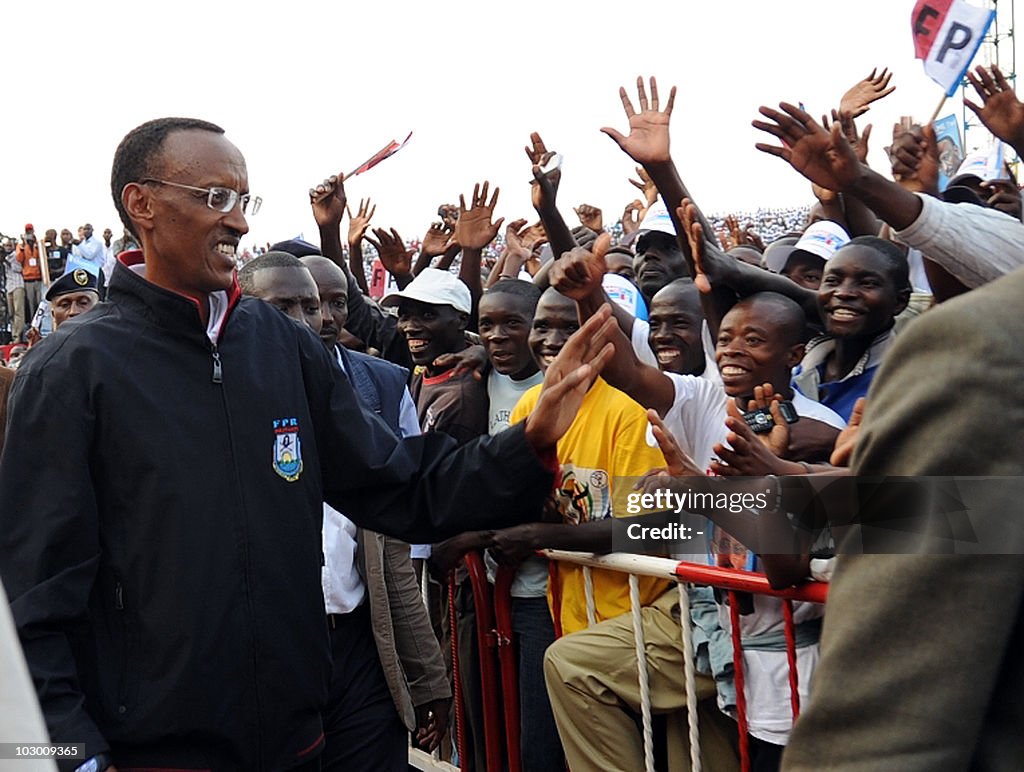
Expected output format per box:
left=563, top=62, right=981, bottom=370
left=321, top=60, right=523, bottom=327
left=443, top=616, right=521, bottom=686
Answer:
left=0, top=0, right=1009, bottom=252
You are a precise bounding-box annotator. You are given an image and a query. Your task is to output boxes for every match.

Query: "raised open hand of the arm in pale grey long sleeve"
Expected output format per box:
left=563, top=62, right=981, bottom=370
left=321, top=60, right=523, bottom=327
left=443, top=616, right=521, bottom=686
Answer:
left=753, top=102, right=862, bottom=192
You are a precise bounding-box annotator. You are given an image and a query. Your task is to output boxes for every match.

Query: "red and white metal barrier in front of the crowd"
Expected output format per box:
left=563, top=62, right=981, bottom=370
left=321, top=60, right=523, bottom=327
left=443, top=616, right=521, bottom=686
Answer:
left=419, top=550, right=828, bottom=772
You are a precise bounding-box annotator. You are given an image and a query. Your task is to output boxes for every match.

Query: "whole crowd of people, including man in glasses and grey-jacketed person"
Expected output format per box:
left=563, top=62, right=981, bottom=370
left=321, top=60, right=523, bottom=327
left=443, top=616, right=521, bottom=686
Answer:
left=0, top=60, right=1024, bottom=772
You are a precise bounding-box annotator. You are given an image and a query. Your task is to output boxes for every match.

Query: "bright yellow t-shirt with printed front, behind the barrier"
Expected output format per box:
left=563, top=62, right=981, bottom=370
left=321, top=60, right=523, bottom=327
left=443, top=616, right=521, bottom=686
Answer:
left=510, top=378, right=672, bottom=634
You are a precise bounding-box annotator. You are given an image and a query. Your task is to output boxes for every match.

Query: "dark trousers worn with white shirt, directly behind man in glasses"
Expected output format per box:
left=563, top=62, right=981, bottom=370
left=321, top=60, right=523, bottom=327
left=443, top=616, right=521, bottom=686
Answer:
left=321, top=603, right=409, bottom=772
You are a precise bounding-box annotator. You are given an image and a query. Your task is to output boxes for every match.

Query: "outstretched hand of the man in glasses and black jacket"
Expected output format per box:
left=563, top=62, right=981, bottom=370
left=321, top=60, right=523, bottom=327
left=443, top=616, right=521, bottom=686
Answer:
left=525, top=304, right=616, bottom=454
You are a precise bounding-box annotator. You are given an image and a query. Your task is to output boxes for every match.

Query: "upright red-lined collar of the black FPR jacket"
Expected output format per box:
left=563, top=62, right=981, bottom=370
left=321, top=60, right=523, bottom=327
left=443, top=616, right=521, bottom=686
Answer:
left=109, top=250, right=242, bottom=343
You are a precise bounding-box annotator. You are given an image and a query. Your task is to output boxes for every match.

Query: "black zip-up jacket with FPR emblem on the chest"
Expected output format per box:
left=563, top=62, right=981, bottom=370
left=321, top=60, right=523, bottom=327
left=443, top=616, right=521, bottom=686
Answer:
left=0, top=259, right=551, bottom=770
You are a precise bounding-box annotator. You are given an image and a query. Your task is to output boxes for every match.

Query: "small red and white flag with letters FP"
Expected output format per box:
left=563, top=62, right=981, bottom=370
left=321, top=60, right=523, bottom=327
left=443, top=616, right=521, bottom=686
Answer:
left=910, top=0, right=995, bottom=96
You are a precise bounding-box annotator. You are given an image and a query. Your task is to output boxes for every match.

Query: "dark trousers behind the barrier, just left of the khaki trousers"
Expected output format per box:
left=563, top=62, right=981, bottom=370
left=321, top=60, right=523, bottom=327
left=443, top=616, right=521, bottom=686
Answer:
left=512, top=596, right=565, bottom=772
